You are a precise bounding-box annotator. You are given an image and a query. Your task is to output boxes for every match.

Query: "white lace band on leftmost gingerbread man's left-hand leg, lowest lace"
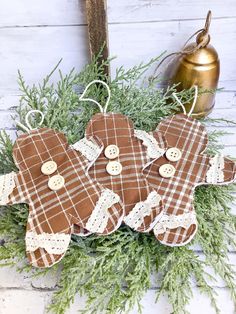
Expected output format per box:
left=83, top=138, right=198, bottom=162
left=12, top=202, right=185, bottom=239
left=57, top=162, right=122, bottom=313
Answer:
left=25, top=231, right=71, bottom=254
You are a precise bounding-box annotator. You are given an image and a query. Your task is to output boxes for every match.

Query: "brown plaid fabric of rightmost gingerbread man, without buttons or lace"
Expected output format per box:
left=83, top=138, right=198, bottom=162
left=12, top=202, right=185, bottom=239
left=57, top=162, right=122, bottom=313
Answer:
left=144, top=114, right=236, bottom=246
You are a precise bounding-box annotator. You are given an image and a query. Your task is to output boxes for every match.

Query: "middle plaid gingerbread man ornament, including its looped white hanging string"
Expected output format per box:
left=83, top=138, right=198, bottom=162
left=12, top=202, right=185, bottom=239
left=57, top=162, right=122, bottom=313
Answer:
left=74, top=81, right=164, bottom=232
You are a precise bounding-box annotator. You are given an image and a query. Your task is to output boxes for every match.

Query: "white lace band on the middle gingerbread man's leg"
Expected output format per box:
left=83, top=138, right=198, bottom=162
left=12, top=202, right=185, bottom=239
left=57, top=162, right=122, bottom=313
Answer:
left=124, top=191, right=161, bottom=230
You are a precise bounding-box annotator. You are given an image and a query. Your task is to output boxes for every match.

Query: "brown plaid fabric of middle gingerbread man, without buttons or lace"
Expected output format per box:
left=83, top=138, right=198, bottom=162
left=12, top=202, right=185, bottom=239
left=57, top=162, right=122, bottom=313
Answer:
left=85, top=113, right=162, bottom=232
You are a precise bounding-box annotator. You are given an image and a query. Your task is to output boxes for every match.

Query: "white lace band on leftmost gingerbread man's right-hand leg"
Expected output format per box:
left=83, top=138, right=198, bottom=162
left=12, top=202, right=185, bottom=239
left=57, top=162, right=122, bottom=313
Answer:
left=85, top=189, right=120, bottom=233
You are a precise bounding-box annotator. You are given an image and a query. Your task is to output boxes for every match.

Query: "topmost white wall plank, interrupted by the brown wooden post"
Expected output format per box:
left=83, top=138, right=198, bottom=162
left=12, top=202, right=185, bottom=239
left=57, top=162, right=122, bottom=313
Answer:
left=0, top=0, right=236, bottom=27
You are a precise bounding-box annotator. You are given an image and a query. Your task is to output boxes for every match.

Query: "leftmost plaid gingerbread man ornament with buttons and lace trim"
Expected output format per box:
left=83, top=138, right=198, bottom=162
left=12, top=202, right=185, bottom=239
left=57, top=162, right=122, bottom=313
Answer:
left=0, top=111, right=123, bottom=267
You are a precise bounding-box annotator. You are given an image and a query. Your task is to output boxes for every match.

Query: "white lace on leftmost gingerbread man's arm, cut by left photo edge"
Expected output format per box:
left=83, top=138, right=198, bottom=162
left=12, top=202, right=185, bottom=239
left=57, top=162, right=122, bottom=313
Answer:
left=0, top=172, right=16, bottom=205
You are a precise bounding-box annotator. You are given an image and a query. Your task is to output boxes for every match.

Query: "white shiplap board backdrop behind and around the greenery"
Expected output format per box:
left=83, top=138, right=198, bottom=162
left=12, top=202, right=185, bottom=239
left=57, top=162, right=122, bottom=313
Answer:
left=0, top=0, right=236, bottom=314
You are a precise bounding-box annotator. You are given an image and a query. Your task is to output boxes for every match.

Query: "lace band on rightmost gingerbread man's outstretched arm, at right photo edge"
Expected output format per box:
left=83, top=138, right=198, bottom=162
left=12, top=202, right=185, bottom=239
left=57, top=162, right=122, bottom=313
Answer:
left=206, top=154, right=224, bottom=184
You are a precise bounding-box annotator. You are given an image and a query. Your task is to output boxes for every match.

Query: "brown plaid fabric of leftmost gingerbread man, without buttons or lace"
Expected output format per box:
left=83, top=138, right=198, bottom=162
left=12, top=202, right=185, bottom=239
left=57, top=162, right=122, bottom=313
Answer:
left=3, top=128, right=123, bottom=267
